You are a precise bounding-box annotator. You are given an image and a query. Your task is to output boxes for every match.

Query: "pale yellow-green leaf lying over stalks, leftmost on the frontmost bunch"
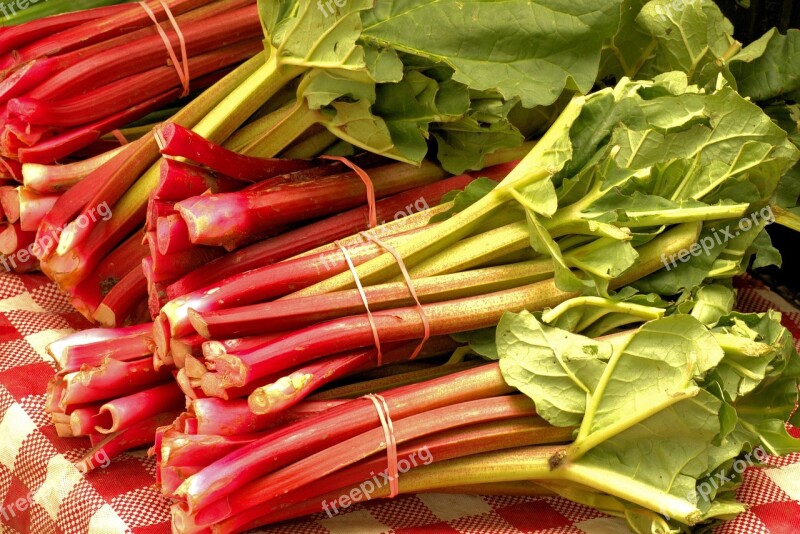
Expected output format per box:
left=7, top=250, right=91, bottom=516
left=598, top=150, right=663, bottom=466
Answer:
left=497, top=312, right=612, bottom=426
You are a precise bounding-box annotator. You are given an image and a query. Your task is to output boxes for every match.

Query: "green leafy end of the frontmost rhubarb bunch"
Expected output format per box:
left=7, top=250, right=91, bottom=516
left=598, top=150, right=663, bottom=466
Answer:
left=497, top=312, right=800, bottom=527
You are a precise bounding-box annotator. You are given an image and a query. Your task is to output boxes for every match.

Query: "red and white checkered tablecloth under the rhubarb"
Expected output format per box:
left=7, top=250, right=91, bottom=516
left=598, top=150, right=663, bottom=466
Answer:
left=0, top=274, right=800, bottom=534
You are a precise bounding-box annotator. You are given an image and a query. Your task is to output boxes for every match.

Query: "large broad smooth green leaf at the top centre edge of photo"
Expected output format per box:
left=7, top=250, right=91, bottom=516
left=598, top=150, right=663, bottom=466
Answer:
left=362, top=0, right=622, bottom=108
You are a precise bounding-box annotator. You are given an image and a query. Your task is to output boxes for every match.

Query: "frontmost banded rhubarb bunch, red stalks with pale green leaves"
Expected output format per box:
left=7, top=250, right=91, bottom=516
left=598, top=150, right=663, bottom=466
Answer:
left=157, top=299, right=800, bottom=533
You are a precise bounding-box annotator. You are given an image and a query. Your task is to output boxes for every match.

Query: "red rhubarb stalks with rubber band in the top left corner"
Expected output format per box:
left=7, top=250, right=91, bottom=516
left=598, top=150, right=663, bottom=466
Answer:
left=0, top=0, right=260, bottom=164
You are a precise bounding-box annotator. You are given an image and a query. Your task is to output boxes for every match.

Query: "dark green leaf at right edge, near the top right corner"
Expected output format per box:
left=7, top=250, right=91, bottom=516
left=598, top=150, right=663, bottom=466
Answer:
left=730, top=28, right=800, bottom=101
